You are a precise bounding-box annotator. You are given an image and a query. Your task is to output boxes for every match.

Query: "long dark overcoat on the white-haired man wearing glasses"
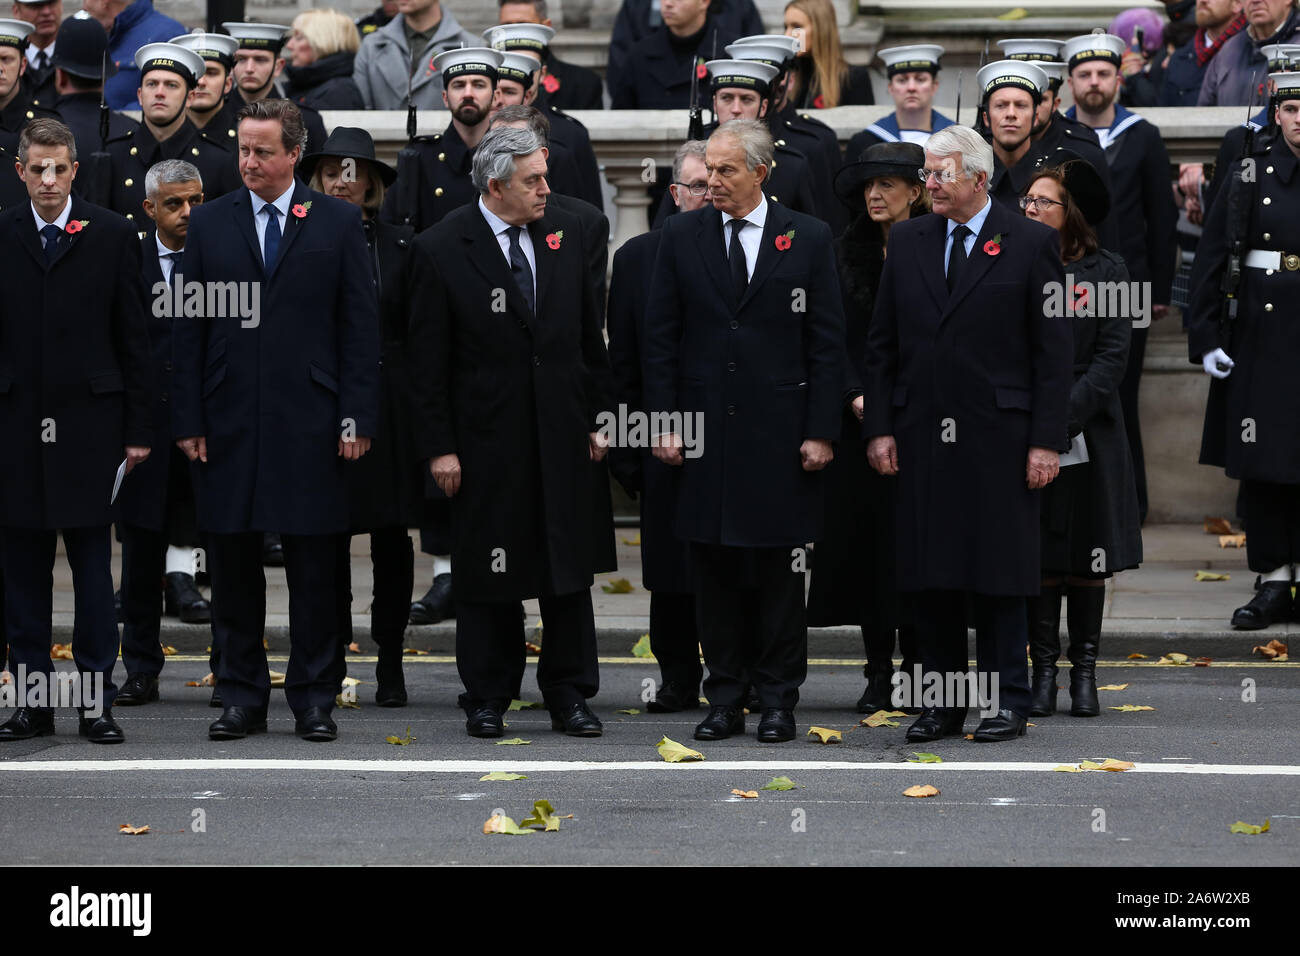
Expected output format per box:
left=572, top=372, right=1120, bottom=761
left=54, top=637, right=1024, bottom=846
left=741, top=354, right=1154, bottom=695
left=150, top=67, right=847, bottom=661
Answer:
left=863, top=200, right=1073, bottom=596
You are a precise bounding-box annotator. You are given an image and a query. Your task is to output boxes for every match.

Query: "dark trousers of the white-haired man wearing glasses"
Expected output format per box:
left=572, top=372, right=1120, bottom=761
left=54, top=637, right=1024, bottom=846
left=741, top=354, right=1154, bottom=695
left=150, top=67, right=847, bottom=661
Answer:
left=909, top=591, right=1030, bottom=717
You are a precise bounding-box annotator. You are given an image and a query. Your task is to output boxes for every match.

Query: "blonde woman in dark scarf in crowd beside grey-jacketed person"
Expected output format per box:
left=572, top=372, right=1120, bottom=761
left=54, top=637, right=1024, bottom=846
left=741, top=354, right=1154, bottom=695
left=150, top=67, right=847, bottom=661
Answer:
left=285, top=10, right=365, bottom=111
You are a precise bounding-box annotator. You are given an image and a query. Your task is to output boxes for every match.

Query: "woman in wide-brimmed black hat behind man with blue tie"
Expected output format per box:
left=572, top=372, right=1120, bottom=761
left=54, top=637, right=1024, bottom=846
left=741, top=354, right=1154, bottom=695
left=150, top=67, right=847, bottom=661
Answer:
left=300, top=126, right=423, bottom=708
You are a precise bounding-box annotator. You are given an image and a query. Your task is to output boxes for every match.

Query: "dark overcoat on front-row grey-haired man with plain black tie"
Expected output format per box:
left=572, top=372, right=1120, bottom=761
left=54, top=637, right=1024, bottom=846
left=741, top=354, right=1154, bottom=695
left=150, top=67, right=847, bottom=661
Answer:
left=644, top=203, right=845, bottom=548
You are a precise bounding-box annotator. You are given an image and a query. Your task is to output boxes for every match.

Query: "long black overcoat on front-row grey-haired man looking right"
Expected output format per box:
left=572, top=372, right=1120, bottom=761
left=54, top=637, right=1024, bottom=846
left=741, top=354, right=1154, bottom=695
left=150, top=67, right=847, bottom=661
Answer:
left=411, top=203, right=611, bottom=602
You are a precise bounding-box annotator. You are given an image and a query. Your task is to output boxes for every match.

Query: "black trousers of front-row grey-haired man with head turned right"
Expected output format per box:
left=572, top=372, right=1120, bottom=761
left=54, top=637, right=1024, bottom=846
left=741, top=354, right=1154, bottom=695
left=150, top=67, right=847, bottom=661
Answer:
left=456, top=589, right=601, bottom=713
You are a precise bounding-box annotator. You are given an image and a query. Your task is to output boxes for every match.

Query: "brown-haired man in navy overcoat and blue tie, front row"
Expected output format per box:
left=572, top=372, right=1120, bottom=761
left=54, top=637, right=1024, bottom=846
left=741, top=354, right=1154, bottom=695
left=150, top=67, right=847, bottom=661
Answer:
left=172, top=99, right=380, bottom=740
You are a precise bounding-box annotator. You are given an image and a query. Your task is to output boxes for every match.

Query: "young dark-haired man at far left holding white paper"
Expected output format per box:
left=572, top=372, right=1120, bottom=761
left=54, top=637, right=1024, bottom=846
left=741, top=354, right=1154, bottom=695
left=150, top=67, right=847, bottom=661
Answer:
left=0, top=118, right=153, bottom=744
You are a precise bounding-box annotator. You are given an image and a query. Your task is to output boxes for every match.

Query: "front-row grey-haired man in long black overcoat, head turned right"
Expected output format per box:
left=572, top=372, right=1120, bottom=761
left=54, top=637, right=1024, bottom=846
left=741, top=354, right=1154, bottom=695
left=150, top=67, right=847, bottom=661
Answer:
left=411, top=127, right=608, bottom=737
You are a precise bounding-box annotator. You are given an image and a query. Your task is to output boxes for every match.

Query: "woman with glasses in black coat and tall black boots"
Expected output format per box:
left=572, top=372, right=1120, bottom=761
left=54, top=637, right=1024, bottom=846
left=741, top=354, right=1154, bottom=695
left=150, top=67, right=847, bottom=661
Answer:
left=1021, top=150, right=1141, bottom=717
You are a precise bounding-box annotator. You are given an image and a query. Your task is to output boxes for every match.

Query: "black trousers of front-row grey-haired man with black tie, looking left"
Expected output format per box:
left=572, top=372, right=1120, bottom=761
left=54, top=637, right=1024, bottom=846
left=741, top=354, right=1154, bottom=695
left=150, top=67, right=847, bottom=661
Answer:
left=690, top=542, right=809, bottom=710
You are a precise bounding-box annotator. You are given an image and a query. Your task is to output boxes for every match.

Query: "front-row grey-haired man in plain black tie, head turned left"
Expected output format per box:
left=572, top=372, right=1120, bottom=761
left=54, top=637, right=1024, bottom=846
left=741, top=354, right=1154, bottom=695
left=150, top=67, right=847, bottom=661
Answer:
left=644, top=120, right=845, bottom=743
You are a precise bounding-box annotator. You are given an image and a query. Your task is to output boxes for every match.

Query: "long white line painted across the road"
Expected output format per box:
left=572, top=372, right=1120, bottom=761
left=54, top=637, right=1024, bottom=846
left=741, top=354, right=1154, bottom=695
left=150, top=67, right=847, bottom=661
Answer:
left=0, top=757, right=1300, bottom=777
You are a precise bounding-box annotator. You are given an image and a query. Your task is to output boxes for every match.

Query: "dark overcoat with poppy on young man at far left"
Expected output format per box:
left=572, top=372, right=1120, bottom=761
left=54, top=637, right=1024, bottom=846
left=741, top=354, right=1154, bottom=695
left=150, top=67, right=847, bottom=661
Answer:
left=0, top=195, right=153, bottom=528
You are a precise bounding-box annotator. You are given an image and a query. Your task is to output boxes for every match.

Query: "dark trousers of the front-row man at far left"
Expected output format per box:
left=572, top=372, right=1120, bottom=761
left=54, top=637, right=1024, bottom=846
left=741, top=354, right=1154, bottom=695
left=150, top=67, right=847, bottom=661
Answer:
left=0, top=524, right=117, bottom=708
